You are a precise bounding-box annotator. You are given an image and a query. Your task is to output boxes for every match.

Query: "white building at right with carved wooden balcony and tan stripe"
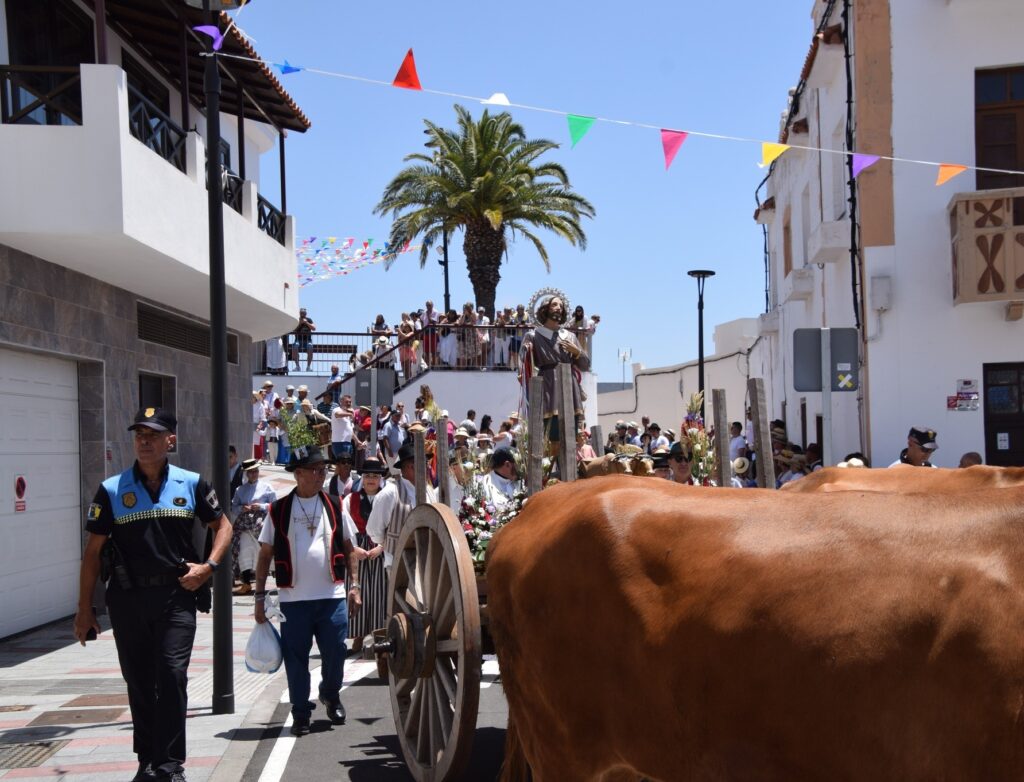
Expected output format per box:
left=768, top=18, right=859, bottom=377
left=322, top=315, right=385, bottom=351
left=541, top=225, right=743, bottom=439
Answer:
left=752, top=0, right=1024, bottom=467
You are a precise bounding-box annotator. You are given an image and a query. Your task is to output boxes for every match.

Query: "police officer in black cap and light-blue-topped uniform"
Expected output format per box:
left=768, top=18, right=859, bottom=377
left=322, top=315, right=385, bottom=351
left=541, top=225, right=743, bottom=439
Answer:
left=75, top=407, right=231, bottom=782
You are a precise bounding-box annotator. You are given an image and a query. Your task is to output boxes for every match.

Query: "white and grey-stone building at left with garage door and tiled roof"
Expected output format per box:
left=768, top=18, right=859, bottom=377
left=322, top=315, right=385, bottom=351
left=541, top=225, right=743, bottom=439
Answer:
left=0, top=0, right=309, bottom=638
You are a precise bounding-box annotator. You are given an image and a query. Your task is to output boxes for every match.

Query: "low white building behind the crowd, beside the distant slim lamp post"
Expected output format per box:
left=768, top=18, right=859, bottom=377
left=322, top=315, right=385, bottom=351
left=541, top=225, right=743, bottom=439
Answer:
left=594, top=317, right=758, bottom=440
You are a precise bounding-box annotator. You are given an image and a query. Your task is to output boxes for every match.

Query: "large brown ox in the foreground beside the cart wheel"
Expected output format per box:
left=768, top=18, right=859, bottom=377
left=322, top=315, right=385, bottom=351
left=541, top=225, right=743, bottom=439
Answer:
left=487, top=471, right=1024, bottom=782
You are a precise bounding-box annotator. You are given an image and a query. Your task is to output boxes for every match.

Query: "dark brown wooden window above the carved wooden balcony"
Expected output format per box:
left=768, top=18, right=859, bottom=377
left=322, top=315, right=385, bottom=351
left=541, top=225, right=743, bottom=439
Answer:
left=974, top=68, right=1024, bottom=190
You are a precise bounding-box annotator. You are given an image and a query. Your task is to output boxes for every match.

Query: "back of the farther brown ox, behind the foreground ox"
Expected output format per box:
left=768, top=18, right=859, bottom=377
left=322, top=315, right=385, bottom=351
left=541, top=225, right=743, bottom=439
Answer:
left=780, top=465, right=1024, bottom=493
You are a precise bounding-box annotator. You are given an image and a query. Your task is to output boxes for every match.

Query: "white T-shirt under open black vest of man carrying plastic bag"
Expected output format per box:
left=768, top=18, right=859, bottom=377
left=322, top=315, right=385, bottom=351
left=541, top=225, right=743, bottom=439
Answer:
left=259, top=494, right=350, bottom=603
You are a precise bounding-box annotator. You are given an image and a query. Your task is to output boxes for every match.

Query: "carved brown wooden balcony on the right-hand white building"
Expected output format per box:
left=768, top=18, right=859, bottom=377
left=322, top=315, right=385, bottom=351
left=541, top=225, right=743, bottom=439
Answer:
left=948, top=187, right=1024, bottom=305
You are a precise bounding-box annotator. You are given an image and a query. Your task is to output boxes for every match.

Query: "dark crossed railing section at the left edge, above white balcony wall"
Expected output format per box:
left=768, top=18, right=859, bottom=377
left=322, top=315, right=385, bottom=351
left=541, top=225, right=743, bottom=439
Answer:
left=0, top=66, right=82, bottom=125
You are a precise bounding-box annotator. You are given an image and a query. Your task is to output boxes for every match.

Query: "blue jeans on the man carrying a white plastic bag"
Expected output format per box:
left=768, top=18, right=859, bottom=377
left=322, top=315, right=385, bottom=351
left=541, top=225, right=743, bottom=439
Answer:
left=281, top=598, right=348, bottom=720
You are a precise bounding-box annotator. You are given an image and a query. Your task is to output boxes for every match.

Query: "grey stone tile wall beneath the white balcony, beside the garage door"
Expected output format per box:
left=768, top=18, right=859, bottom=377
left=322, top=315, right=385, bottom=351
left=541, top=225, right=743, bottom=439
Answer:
left=0, top=245, right=253, bottom=518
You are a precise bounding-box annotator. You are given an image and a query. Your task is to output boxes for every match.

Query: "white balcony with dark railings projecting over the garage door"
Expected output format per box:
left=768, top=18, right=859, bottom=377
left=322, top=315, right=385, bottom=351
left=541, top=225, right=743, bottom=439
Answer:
left=0, top=64, right=298, bottom=339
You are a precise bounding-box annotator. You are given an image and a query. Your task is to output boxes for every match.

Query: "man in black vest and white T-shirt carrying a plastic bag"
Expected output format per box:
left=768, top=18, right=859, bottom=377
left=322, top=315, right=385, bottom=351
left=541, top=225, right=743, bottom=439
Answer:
left=255, top=446, right=362, bottom=736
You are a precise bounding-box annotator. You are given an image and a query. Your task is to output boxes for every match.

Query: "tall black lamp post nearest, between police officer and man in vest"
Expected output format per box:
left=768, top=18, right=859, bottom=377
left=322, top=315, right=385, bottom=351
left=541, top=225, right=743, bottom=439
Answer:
left=186, top=0, right=239, bottom=714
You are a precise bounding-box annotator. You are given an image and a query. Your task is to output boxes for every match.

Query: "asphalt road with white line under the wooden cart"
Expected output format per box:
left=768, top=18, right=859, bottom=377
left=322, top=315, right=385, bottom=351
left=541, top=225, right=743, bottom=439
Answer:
left=242, top=661, right=508, bottom=782
